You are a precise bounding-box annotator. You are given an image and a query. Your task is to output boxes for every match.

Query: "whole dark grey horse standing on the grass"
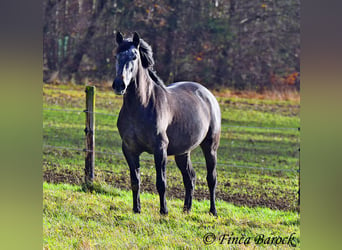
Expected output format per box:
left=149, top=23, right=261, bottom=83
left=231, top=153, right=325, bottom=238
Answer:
left=112, top=32, right=221, bottom=216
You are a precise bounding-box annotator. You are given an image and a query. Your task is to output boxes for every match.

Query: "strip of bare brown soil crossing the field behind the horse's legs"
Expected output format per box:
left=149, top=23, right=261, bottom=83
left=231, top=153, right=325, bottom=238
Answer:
left=43, top=169, right=299, bottom=211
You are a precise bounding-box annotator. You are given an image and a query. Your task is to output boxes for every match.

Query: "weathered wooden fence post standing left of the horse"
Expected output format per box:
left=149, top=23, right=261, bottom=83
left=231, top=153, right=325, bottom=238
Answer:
left=84, top=86, right=95, bottom=187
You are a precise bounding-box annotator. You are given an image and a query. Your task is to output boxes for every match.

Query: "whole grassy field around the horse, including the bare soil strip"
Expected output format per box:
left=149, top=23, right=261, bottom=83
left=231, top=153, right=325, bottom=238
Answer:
left=43, top=85, right=300, bottom=249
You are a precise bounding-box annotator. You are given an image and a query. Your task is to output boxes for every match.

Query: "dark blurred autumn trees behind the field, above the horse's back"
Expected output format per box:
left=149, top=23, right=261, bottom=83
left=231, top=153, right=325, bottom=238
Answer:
left=43, top=0, right=300, bottom=91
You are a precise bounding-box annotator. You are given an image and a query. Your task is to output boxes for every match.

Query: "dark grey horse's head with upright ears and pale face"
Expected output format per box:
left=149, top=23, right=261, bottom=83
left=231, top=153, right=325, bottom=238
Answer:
left=112, top=32, right=140, bottom=95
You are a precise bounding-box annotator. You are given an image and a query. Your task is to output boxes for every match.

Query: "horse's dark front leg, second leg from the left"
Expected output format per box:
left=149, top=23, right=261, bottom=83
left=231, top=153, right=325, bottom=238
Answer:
left=154, top=136, right=168, bottom=214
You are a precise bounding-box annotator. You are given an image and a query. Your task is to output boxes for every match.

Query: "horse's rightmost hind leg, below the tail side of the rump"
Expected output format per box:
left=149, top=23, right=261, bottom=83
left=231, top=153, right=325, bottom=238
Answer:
left=201, top=134, right=219, bottom=216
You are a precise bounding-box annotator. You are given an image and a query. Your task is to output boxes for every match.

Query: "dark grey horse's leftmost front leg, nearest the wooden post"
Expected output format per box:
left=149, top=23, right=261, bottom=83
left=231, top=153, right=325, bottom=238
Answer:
left=122, top=144, right=141, bottom=213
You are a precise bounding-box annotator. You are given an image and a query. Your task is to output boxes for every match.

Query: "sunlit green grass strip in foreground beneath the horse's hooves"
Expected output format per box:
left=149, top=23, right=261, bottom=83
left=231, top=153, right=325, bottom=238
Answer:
left=43, top=183, right=300, bottom=249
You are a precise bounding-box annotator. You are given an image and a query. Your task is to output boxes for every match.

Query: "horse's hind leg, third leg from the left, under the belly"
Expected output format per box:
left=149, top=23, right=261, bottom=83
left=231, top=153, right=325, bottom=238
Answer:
left=175, top=153, right=196, bottom=212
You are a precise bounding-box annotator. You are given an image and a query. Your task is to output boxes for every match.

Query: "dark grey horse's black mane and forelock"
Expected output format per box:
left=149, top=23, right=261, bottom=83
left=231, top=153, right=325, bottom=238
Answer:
left=117, top=35, right=165, bottom=87
